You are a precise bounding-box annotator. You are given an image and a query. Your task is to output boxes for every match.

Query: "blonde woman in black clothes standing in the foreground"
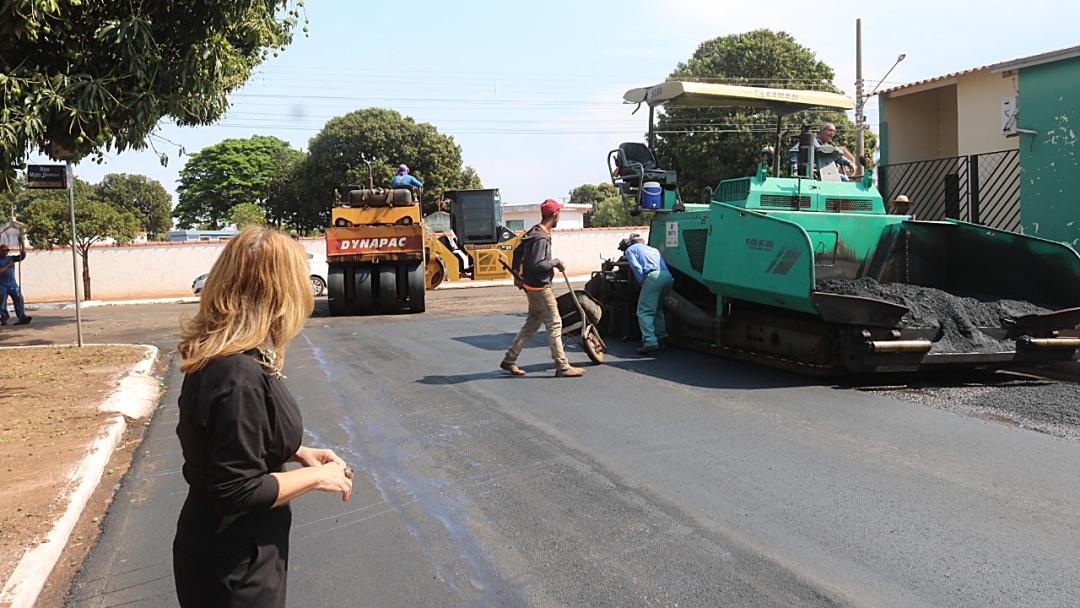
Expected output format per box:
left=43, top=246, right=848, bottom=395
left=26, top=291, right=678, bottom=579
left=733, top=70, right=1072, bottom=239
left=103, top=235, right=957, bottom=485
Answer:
left=173, top=227, right=352, bottom=608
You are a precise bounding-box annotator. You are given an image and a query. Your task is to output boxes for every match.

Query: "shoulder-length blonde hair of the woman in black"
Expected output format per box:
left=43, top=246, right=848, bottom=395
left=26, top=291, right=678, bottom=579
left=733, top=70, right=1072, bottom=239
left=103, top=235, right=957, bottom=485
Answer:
left=177, top=226, right=314, bottom=374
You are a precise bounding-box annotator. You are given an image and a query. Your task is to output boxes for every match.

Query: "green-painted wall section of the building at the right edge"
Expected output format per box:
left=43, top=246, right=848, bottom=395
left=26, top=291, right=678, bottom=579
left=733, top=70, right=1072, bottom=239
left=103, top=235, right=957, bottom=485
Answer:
left=1018, top=57, right=1080, bottom=251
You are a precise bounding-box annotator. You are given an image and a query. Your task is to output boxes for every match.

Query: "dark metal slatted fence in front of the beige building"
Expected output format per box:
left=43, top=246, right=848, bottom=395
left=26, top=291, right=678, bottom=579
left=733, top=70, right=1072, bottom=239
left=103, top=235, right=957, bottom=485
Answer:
left=878, top=150, right=1021, bottom=232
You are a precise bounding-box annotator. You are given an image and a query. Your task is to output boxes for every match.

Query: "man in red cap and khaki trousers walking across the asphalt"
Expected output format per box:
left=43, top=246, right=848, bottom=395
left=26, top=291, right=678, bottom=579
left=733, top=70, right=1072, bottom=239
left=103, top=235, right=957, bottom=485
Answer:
left=499, top=199, right=585, bottom=378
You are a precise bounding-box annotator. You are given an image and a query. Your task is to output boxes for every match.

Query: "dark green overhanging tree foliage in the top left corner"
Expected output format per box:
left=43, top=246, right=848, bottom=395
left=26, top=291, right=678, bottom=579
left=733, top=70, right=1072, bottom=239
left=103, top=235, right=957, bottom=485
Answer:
left=0, top=0, right=307, bottom=190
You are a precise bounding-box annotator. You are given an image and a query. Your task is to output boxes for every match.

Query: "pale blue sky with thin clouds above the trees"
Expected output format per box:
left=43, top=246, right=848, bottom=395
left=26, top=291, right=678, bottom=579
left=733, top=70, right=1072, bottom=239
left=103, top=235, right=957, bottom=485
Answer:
left=42, top=0, right=1080, bottom=211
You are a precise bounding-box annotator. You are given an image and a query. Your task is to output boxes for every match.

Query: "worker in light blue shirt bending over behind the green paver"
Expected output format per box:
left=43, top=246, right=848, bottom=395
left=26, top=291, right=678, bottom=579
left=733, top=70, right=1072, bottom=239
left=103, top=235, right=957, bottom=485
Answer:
left=625, top=232, right=675, bottom=354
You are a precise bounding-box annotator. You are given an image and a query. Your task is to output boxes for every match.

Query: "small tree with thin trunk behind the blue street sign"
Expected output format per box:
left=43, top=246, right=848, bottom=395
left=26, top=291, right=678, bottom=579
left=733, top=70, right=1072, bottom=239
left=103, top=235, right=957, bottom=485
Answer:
left=19, top=177, right=139, bottom=300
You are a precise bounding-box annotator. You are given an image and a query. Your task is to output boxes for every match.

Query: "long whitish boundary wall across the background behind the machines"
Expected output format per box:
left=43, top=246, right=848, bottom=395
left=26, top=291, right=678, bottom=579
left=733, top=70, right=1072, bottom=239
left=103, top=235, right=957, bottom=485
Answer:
left=15, top=227, right=649, bottom=303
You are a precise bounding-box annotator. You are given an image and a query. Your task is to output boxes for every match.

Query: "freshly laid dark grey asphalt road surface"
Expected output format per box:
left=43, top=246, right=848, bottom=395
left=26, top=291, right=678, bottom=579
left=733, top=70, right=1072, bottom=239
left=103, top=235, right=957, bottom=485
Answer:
left=70, top=306, right=1080, bottom=608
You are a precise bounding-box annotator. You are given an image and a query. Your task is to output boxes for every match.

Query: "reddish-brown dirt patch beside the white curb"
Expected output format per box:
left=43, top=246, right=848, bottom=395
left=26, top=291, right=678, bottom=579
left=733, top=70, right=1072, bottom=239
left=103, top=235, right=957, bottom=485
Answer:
left=0, top=346, right=146, bottom=596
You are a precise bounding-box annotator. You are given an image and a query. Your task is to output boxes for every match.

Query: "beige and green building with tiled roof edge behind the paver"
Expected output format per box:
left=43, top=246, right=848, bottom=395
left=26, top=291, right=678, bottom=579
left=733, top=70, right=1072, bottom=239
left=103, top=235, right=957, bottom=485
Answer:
left=878, top=45, right=1080, bottom=247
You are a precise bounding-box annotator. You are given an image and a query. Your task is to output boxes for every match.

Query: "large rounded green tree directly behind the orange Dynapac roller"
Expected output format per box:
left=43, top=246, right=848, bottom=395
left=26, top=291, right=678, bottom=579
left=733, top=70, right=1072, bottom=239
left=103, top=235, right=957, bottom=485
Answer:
left=303, top=108, right=480, bottom=220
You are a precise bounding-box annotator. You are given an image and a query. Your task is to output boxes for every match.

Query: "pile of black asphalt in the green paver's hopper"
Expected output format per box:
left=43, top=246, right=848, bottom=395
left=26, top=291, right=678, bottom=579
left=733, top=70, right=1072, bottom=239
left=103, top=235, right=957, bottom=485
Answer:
left=818, top=278, right=1047, bottom=354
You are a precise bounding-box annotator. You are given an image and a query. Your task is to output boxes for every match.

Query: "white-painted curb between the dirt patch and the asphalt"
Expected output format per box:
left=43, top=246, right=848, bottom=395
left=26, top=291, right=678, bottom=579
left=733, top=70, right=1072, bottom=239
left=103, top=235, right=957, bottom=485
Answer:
left=0, top=344, right=160, bottom=608
